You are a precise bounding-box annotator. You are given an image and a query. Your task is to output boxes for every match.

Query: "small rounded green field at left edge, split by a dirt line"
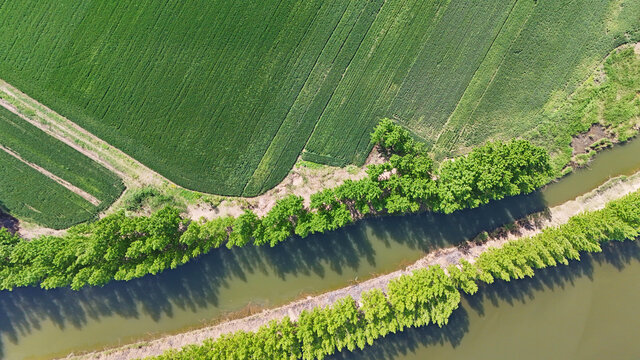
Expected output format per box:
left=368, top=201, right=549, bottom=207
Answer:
left=0, top=107, right=124, bottom=229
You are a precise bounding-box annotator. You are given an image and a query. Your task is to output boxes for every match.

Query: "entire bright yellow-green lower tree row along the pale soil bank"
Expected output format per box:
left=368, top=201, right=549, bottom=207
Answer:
left=148, top=188, right=640, bottom=360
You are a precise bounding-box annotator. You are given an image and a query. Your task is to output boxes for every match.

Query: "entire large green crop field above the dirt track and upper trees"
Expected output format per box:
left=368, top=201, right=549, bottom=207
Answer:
left=0, top=0, right=640, bottom=196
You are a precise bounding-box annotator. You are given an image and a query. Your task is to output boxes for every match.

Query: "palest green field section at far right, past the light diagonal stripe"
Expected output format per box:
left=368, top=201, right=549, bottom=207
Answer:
left=436, top=0, right=640, bottom=156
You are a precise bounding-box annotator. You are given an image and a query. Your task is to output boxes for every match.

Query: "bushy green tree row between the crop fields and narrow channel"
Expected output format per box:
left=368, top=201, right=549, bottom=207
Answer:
left=0, top=119, right=550, bottom=289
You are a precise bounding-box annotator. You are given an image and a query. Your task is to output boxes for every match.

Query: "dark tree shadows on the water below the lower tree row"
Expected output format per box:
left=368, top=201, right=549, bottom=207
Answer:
left=329, top=240, right=640, bottom=360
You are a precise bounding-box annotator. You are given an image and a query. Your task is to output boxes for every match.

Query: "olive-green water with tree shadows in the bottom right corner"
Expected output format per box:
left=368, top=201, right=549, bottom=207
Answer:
left=330, top=241, right=640, bottom=360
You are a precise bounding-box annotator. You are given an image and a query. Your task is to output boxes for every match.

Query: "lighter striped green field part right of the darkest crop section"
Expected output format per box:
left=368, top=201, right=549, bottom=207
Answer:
left=304, top=0, right=640, bottom=165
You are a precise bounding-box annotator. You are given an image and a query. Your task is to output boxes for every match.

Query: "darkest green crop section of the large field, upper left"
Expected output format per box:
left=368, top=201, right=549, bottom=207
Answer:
left=0, top=0, right=381, bottom=196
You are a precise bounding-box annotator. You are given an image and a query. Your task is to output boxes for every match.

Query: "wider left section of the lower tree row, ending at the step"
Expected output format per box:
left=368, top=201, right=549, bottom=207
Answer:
left=157, top=266, right=460, bottom=360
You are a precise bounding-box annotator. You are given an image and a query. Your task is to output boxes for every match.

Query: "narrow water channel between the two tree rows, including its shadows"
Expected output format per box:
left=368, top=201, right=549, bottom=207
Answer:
left=0, top=140, right=640, bottom=359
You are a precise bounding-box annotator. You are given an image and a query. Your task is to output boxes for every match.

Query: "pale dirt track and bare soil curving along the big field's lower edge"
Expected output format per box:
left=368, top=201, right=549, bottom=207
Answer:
left=0, top=80, right=383, bottom=238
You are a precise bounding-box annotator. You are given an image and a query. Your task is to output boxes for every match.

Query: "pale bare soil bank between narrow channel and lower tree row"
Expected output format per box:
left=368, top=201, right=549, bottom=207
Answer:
left=68, top=172, right=640, bottom=360
